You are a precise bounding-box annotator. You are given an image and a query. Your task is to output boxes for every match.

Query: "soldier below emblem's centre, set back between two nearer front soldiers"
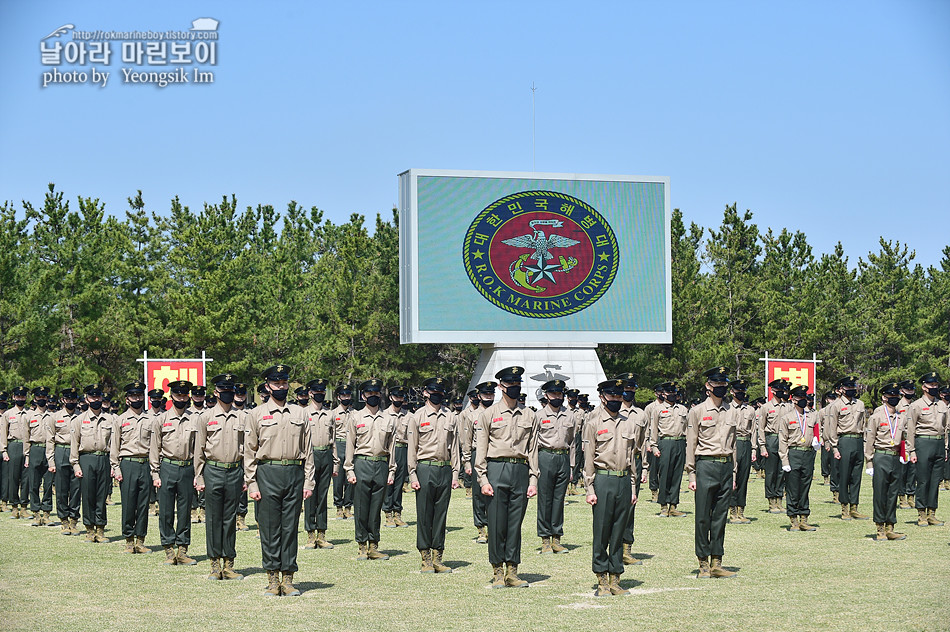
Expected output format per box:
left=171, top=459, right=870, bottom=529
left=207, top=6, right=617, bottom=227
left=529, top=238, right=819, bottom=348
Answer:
left=537, top=380, right=577, bottom=554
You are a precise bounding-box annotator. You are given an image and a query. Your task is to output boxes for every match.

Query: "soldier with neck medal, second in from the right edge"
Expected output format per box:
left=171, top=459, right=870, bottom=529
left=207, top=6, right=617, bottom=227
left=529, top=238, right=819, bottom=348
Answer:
left=863, top=382, right=910, bottom=542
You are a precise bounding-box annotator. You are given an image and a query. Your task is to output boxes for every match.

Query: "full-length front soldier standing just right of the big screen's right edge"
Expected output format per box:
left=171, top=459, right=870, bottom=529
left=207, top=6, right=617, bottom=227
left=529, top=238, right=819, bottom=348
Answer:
left=686, top=366, right=744, bottom=579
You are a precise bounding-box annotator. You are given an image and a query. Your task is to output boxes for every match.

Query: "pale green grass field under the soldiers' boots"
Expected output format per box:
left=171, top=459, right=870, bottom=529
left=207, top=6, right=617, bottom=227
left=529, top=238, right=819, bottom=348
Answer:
left=0, top=466, right=950, bottom=632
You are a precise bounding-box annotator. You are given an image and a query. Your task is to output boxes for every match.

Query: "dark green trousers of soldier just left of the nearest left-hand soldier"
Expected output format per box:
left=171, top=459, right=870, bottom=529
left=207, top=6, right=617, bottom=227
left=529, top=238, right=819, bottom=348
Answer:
left=204, top=464, right=244, bottom=560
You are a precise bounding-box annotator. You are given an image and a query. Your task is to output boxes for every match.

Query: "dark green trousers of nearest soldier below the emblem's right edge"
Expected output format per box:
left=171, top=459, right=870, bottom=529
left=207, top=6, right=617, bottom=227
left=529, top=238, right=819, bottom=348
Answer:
left=591, top=474, right=633, bottom=575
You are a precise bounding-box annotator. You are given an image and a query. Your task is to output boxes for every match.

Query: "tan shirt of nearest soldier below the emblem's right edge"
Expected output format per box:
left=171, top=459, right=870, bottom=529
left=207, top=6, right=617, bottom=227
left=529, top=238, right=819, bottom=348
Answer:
left=583, top=406, right=646, bottom=493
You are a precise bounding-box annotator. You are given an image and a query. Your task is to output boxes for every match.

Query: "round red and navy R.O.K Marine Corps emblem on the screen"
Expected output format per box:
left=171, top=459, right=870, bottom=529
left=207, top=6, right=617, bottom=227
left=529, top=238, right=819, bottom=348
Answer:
left=462, top=191, right=620, bottom=318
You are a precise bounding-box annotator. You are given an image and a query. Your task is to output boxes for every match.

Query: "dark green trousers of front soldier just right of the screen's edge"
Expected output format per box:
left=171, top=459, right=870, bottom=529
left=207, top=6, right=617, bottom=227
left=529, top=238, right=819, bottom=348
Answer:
left=695, top=460, right=732, bottom=558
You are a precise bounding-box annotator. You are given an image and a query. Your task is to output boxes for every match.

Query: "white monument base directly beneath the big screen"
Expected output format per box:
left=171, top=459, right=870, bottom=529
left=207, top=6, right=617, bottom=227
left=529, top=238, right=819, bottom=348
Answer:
left=468, top=344, right=607, bottom=408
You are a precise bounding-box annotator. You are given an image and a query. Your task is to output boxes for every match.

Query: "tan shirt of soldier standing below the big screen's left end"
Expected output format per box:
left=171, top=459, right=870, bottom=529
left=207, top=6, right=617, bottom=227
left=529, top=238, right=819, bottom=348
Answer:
left=406, top=404, right=464, bottom=484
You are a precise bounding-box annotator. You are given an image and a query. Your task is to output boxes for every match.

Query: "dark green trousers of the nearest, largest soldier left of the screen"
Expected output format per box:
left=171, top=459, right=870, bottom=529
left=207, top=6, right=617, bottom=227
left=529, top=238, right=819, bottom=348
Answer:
left=257, top=463, right=304, bottom=573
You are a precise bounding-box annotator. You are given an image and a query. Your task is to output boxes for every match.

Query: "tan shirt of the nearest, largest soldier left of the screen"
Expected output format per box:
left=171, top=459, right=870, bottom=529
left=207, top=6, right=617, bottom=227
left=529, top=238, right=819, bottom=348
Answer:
left=244, top=399, right=315, bottom=493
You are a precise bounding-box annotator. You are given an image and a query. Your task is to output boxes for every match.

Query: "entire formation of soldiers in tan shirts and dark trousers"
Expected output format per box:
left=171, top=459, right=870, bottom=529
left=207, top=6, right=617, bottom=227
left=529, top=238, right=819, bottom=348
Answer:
left=0, top=365, right=950, bottom=596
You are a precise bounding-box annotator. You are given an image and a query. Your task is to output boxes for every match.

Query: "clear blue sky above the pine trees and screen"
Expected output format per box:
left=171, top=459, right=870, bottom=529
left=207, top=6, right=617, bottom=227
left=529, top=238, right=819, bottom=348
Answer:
left=0, top=0, right=950, bottom=265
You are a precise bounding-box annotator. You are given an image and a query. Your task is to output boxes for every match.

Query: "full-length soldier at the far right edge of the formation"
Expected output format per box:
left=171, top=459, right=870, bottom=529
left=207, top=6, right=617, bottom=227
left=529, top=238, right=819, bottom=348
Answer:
left=906, top=371, right=948, bottom=527
